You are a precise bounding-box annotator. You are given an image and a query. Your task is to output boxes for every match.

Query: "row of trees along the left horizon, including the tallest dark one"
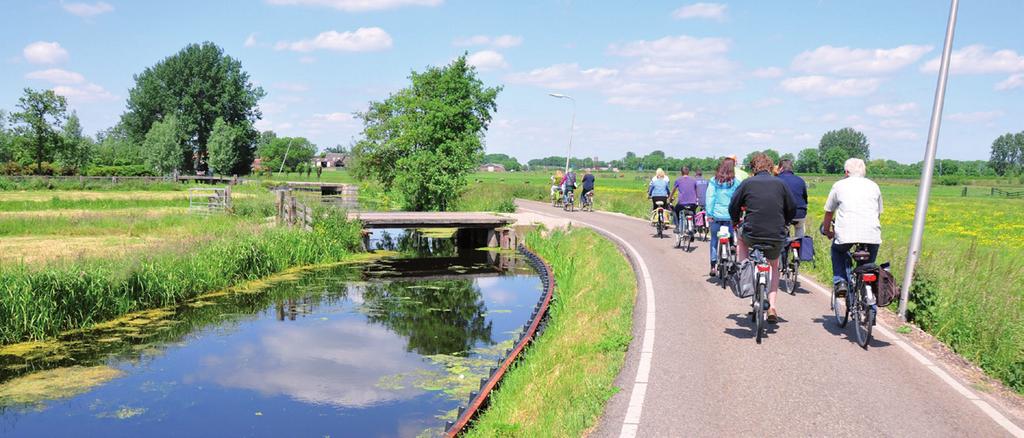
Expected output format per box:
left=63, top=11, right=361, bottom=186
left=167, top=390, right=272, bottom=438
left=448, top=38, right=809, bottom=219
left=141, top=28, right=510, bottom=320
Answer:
left=0, top=42, right=316, bottom=176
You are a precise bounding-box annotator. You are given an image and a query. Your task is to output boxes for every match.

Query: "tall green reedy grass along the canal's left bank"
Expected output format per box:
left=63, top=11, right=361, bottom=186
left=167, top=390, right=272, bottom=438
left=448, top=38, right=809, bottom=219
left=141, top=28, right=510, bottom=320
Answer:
left=0, top=206, right=359, bottom=344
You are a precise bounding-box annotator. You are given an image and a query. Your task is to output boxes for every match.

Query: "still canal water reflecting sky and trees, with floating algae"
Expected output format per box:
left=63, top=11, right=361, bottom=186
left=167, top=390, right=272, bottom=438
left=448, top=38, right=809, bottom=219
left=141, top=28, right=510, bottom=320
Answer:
left=0, top=231, right=542, bottom=437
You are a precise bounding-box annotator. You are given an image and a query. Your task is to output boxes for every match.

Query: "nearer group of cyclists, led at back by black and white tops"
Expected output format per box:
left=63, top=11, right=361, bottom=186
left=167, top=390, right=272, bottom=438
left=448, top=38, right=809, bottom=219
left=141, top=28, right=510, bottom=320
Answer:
left=647, top=154, right=882, bottom=323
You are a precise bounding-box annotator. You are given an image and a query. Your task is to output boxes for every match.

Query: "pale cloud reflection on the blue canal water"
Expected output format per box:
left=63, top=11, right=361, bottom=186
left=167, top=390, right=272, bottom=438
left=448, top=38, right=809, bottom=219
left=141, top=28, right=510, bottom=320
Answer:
left=201, top=319, right=423, bottom=408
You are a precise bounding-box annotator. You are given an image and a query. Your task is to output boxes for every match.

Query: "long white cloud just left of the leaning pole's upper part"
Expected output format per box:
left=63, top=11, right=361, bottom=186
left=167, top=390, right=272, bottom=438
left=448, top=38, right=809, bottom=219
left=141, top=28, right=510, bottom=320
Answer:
left=793, top=45, right=932, bottom=76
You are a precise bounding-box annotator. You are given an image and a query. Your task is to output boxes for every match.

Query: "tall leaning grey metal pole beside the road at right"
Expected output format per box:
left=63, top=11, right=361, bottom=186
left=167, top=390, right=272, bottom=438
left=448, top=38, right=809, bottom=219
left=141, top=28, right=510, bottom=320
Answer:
left=899, top=0, right=959, bottom=320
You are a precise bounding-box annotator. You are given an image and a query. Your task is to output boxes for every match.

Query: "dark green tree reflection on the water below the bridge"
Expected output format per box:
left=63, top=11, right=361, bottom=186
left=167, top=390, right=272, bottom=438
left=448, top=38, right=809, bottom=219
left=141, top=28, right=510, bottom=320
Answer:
left=362, top=279, right=494, bottom=355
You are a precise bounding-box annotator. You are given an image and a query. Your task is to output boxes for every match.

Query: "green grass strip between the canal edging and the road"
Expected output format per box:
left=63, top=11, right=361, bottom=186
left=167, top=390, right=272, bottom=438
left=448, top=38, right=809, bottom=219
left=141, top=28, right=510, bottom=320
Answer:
left=467, top=229, right=636, bottom=437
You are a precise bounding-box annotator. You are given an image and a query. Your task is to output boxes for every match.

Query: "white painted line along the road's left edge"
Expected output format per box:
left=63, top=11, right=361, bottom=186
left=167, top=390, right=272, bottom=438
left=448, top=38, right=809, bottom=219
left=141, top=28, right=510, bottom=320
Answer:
left=520, top=207, right=656, bottom=438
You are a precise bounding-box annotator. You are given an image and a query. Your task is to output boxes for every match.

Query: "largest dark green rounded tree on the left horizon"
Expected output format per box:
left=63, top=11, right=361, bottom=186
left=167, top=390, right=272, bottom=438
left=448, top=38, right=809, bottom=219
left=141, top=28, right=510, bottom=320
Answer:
left=121, top=42, right=264, bottom=172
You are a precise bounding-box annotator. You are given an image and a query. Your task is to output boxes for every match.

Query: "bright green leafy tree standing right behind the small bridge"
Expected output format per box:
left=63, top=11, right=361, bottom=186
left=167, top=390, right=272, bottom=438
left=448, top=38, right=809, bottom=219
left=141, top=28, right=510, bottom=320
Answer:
left=353, top=54, right=502, bottom=211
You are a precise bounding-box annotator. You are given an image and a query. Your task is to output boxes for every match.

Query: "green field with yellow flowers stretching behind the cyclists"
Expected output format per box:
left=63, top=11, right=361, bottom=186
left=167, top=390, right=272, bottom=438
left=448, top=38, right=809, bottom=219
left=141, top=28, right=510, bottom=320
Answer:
left=468, top=170, right=1024, bottom=392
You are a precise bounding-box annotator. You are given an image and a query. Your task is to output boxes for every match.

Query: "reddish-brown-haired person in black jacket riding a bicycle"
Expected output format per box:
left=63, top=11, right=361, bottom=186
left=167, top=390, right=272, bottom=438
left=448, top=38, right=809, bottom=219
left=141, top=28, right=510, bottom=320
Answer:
left=729, top=154, right=797, bottom=322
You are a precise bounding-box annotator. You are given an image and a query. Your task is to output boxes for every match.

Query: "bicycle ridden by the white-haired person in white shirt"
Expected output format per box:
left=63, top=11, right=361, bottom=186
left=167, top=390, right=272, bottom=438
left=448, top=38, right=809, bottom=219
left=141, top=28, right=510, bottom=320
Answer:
left=831, top=244, right=880, bottom=350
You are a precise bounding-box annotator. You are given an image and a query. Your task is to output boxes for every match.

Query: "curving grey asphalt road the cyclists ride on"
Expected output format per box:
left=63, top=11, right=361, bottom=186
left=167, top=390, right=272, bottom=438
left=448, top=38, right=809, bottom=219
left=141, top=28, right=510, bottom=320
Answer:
left=518, top=201, right=1024, bottom=438
